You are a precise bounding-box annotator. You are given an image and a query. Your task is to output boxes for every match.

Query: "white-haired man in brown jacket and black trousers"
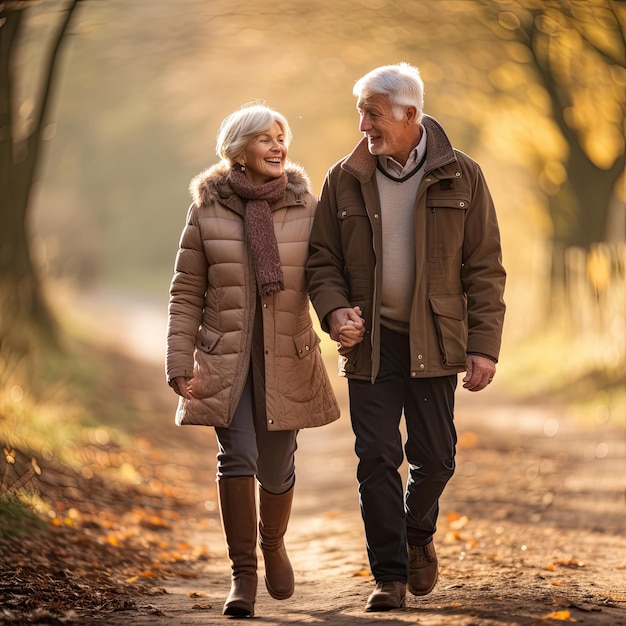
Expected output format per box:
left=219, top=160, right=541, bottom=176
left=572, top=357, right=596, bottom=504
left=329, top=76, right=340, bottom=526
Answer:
left=307, top=63, right=505, bottom=611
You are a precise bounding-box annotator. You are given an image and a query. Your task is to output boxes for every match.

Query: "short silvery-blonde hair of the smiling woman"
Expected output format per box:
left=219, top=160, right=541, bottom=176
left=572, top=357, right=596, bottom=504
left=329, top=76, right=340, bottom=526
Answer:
left=215, top=102, right=292, bottom=166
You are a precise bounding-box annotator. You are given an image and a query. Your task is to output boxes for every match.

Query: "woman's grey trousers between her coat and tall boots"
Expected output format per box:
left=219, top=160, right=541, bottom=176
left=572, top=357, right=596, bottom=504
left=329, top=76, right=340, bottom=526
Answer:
left=215, top=374, right=298, bottom=494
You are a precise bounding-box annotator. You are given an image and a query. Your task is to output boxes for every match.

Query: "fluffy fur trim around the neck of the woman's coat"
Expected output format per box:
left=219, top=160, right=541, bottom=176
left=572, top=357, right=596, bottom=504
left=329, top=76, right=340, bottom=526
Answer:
left=189, top=161, right=312, bottom=206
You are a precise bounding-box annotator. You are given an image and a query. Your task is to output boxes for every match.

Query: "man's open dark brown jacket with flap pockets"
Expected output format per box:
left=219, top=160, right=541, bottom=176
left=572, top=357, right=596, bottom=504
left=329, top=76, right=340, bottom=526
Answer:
left=307, top=116, right=505, bottom=381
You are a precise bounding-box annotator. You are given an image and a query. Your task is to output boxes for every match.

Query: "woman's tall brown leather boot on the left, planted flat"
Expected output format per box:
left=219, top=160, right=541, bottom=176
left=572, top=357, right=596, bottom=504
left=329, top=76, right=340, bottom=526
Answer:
left=217, top=476, right=257, bottom=617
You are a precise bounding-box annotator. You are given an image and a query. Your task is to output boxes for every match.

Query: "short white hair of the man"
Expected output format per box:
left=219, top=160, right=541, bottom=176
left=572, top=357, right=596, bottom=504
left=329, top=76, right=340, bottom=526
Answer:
left=352, top=63, right=424, bottom=124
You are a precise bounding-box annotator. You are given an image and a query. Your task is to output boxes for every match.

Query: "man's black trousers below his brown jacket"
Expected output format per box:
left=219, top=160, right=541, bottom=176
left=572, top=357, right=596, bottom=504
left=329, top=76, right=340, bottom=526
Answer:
left=348, top=328, right=457, bottom=582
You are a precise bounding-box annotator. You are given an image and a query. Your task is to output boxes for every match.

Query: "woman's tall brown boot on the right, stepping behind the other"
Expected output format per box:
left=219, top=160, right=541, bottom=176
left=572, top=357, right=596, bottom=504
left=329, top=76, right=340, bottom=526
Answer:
left=259, top=487, right=295, bottom=600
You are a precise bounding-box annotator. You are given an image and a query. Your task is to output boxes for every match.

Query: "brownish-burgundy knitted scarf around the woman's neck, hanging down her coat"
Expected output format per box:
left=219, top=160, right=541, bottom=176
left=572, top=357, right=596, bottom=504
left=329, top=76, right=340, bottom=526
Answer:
left=228, top=168, right=287, bottom=296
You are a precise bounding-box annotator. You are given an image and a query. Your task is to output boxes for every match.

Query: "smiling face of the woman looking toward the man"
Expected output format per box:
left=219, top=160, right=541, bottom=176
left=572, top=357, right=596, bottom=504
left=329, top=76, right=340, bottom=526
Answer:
left=239, top=122, right=287, bottom=185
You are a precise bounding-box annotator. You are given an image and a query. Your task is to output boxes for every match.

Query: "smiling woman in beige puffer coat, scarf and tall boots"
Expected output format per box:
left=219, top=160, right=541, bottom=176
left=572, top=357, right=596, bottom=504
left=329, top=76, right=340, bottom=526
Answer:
left=166, top=104, right=339, bottom=617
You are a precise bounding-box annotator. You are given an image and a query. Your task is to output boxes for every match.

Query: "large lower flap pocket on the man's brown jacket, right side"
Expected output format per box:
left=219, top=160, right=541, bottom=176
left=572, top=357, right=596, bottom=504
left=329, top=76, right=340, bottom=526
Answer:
left=430, top=295, right=467, bottom=367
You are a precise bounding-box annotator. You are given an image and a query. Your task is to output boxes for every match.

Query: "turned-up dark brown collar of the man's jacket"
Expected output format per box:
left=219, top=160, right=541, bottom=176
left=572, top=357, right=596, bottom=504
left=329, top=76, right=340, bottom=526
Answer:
left=341, top=115, right=456, bottom=183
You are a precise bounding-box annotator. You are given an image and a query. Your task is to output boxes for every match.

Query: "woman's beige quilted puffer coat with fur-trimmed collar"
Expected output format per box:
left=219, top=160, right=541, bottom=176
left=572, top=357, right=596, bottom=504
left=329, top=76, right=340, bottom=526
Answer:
left=166, top=163, right=339, bottom=430
